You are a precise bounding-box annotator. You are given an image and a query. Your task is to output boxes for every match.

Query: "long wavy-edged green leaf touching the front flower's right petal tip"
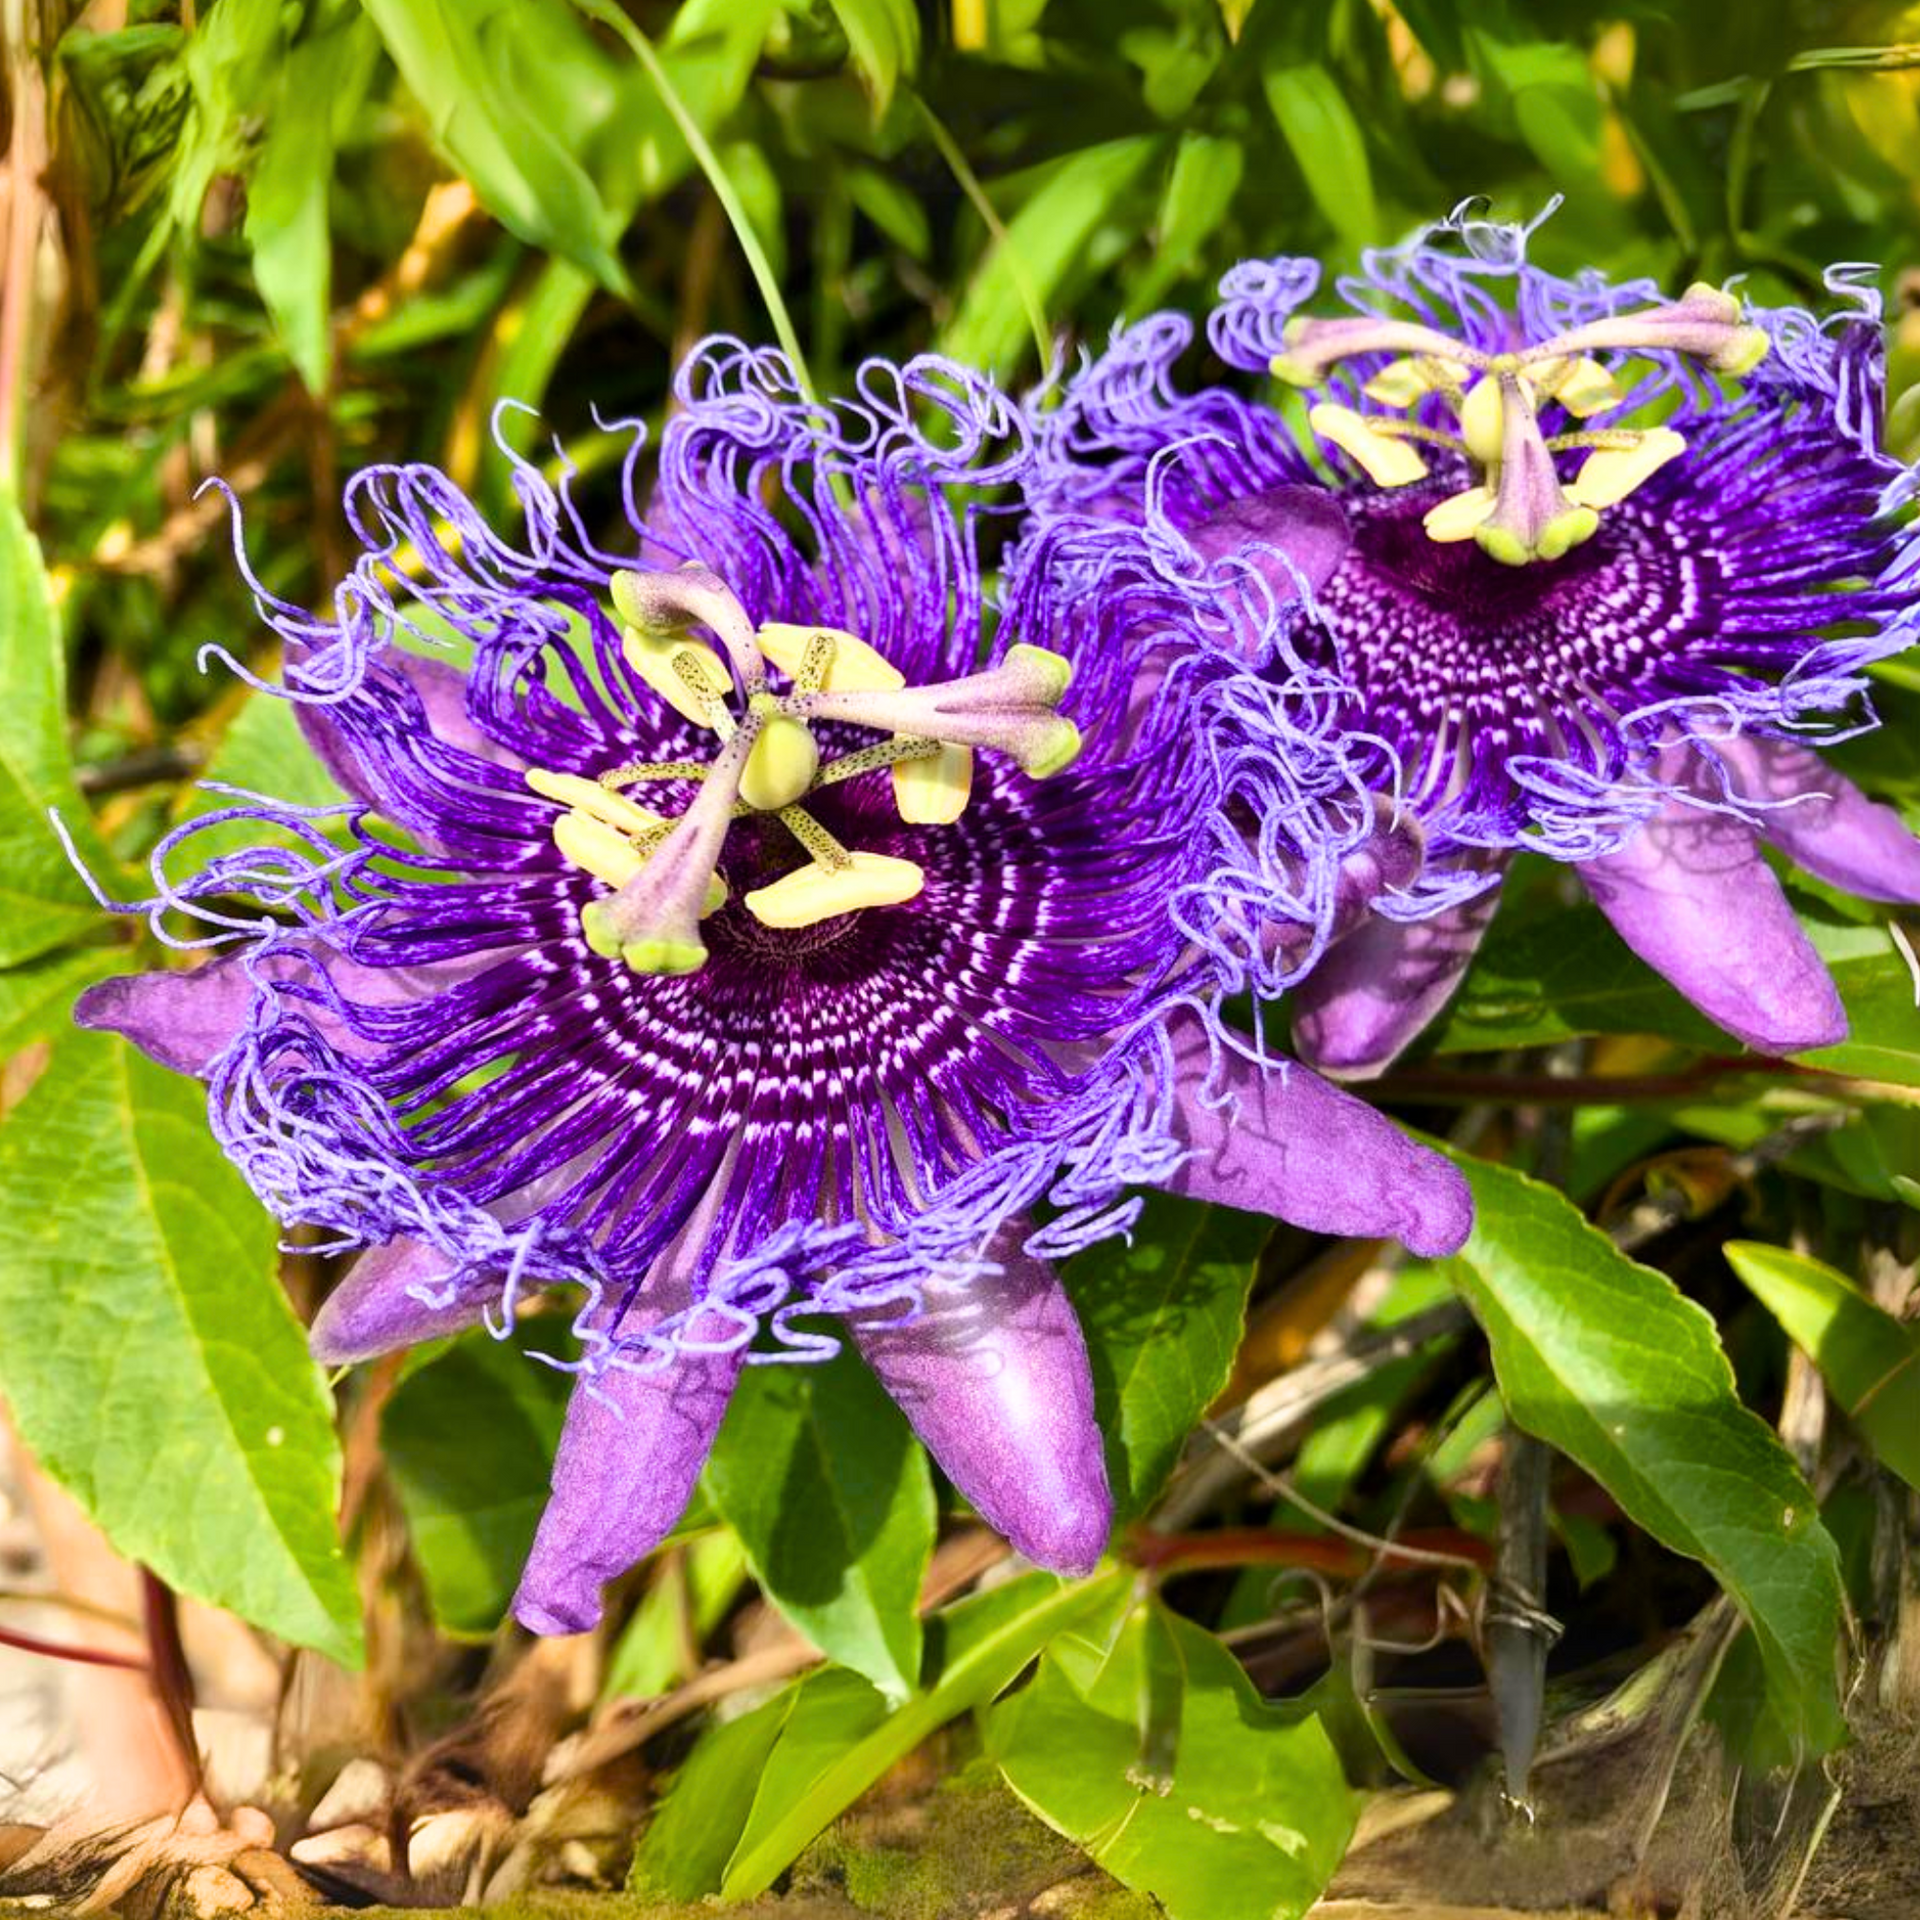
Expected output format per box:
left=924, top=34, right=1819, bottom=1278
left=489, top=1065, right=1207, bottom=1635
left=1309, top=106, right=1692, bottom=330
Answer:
left=1436, top=1142, right=1843, bottom=1749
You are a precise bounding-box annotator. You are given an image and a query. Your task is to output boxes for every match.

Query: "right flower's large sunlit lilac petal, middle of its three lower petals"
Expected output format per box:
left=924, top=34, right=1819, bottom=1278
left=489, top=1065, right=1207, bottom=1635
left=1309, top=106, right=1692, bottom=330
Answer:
left=1580, top=799, right=1847, bottom=1054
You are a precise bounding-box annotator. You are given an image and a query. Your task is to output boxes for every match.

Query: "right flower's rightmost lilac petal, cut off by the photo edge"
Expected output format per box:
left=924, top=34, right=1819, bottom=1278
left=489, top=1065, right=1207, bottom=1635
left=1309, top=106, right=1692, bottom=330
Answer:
left=1715, top=735, right=1920, bottom=904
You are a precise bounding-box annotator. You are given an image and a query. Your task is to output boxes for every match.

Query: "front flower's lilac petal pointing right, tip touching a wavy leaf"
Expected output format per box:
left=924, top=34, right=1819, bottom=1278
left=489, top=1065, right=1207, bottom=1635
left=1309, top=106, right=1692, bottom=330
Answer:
left=1167, top=1014, right=1473, bottom=1258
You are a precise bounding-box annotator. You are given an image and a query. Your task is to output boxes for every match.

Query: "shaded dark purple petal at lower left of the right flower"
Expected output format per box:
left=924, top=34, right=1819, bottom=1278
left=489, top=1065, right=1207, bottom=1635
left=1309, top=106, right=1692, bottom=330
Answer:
left=1294, top=889, right=1500, bottom=1079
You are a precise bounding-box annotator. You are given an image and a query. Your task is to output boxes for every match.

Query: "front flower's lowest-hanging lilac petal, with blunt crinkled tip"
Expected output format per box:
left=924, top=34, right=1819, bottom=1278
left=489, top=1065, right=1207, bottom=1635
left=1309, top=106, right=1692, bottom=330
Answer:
left=513, top=1348, right=747, bottom=1634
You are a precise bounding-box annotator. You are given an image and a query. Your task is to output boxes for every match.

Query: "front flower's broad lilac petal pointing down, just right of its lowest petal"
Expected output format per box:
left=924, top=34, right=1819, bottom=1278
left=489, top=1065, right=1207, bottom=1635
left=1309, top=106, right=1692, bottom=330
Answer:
left=854, top=1219, right=1114, bottom=1574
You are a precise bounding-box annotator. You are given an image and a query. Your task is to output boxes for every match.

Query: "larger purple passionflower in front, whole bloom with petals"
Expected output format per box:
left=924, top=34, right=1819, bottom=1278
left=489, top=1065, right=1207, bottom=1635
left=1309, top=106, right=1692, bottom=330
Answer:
left=67, top=342, right=1469, bottom=1632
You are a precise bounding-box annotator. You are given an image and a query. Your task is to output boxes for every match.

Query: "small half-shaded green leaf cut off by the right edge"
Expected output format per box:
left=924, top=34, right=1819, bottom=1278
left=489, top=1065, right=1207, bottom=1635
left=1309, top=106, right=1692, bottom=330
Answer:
left=1726, top=1240, right=1920, bottom=1488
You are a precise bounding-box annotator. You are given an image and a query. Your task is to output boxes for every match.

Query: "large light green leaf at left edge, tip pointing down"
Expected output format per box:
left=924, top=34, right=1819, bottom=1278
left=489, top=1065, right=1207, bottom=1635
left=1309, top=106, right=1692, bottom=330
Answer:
left=0, top=1033, right=361, bottom=1663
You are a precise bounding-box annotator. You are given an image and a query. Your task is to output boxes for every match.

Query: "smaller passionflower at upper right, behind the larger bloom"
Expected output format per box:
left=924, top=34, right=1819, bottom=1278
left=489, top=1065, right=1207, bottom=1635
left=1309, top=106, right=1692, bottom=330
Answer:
left=1031, top=215, right=1920, bottom=1077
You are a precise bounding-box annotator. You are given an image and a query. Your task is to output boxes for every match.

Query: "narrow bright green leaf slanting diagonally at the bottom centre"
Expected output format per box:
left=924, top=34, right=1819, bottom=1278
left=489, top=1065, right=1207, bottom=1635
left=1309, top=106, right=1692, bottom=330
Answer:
left=718, top=1569, right=1133, bottom=1901
